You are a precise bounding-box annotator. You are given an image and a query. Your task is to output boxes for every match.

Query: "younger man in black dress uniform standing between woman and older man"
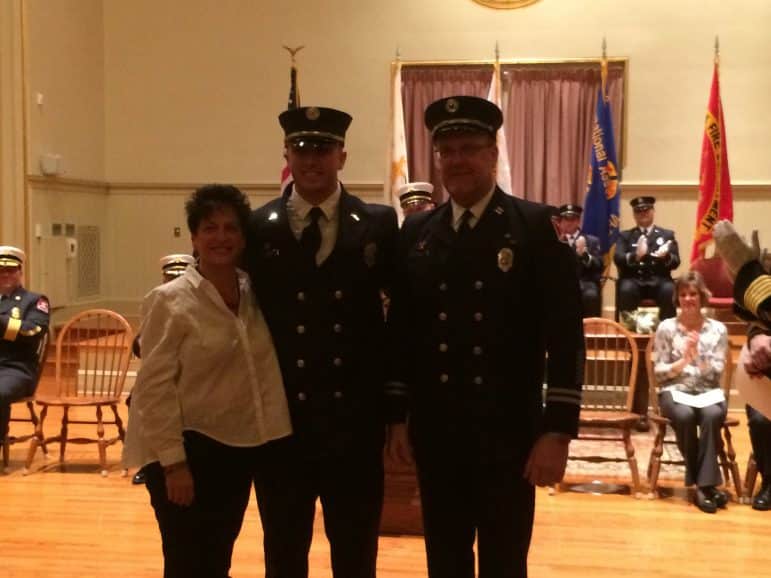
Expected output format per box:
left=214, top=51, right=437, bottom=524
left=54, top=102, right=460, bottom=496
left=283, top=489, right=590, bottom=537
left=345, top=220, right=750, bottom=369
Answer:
left=248, top=107, right=398, bottom=578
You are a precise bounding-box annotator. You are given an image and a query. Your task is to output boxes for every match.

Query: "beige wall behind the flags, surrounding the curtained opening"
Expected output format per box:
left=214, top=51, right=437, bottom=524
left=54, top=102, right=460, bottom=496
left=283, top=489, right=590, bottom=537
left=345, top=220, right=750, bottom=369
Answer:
left=9, top=0, right=771, bottom=312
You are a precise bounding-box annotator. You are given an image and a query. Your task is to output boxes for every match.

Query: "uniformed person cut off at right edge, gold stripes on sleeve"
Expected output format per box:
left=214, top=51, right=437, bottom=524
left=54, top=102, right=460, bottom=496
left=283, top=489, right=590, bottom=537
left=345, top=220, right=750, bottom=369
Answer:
left=714, top=221, right=771, bottom=511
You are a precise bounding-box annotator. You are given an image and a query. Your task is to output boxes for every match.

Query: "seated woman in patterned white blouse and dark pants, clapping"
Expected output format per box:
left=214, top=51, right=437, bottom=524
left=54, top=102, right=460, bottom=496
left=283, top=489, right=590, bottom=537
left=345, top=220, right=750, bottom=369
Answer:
left=654, top=271, right=728, bottom=514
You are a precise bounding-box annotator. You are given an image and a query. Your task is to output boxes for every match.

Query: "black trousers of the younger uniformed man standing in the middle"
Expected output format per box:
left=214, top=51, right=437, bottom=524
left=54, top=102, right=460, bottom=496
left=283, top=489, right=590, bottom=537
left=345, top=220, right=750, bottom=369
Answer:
left=254, top=438, right=383, bottom=578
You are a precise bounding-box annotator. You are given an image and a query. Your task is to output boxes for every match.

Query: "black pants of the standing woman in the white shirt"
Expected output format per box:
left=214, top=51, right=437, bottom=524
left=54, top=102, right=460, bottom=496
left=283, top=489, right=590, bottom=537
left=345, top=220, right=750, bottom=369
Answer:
left=144, top=432, right=259, bottom=578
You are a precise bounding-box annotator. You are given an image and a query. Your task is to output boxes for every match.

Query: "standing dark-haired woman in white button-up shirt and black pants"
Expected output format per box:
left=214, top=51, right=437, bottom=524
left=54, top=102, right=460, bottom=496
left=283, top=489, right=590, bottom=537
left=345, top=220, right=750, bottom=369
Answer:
left=124, top=185, right=291, bottom=578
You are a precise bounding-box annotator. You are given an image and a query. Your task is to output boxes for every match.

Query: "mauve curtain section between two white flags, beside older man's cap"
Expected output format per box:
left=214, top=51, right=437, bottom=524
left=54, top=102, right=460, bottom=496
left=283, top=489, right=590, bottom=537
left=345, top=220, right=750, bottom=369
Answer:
left=402, top=66, right=493, bottom=203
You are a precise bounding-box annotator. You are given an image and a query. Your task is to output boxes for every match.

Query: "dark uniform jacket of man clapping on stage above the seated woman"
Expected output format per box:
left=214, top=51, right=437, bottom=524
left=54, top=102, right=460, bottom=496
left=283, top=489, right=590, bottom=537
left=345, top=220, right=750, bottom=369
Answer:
left=613, top=225, right=680, bottom=285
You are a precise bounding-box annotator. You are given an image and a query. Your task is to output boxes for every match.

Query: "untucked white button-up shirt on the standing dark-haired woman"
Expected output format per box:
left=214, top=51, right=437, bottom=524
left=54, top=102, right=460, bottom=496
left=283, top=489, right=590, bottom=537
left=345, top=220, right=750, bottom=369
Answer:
left=123, top=267, right=291, bottom=467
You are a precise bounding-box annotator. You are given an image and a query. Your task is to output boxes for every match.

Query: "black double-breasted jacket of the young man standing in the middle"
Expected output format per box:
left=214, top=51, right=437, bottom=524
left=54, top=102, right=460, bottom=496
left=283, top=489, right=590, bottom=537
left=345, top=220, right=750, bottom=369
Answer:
left=247, top=188, right=398, bottom=455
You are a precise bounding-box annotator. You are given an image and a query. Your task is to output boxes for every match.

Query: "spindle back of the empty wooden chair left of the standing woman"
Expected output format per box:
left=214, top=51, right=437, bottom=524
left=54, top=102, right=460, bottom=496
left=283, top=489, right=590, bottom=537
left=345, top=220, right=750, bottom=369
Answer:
left=56, top=309, right=133, bottom=399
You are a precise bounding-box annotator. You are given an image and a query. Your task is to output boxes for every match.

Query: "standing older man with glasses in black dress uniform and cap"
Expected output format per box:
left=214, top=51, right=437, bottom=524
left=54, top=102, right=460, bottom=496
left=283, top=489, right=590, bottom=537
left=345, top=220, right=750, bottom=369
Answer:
left=389, top=96, right=583, bottom=578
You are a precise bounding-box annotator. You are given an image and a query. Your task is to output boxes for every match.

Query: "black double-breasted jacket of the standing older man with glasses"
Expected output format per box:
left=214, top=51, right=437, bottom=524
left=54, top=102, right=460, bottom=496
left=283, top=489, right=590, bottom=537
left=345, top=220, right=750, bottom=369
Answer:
left=389, top=189, right=584, bottom=464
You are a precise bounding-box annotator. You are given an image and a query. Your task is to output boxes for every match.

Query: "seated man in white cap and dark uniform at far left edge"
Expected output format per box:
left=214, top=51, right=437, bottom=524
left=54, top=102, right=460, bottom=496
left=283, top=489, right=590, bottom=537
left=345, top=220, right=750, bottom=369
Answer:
left=0, top=246, right=49, bottom=446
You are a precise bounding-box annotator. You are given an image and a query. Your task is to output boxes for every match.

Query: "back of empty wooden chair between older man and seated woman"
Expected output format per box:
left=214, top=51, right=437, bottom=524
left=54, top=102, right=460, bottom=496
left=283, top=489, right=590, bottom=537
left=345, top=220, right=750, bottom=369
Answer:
left=581, top=317, right=639, bottom=412
